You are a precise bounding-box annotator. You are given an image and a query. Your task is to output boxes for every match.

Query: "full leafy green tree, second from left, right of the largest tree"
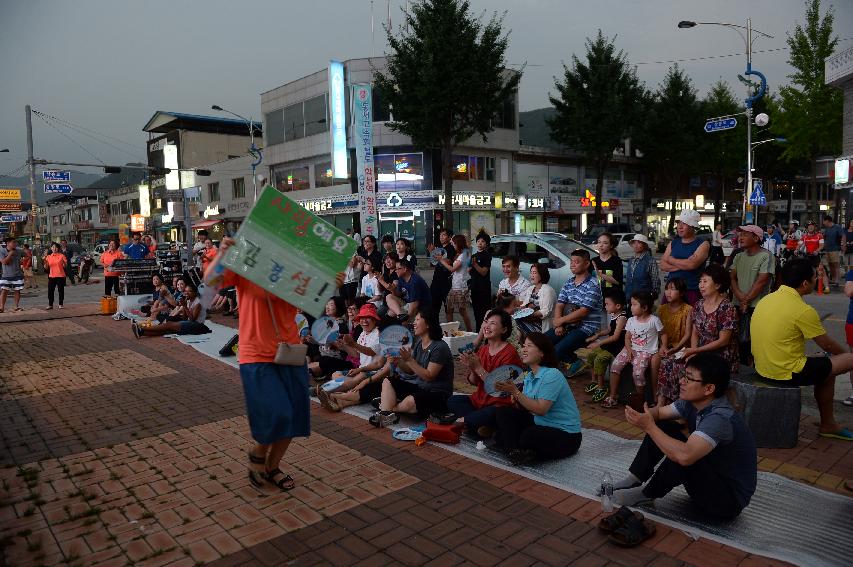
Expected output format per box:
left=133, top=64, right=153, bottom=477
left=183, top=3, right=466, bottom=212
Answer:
left=548, top=30, right=643, bottom=222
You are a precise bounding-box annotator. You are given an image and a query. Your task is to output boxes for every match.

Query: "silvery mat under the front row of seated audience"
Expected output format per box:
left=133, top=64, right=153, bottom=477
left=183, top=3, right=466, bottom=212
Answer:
left=344, top=405, right=853, bottom=567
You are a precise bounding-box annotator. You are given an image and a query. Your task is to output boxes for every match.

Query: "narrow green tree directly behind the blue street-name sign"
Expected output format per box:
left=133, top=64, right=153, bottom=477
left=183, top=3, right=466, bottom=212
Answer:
left=702, top=79, right=746, bottom=225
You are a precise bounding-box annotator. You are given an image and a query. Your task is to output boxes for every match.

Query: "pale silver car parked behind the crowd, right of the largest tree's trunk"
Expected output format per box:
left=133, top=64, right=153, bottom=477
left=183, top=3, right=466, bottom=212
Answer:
left=489, top=232, right=598, bottom=291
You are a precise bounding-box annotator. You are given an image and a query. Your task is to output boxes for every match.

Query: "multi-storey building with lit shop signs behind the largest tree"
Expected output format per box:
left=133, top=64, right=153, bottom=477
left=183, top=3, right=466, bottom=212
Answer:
left=261, top=58, right=519, bottom=253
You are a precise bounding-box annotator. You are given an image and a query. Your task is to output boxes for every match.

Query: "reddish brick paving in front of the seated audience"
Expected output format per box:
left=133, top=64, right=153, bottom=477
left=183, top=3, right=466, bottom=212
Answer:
left=0, top=316, right=840, bottom=565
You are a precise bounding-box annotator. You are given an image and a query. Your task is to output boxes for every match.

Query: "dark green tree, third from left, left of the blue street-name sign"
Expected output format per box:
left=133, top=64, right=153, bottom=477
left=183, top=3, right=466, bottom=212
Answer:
left=636, top=65, right=705, bottom=232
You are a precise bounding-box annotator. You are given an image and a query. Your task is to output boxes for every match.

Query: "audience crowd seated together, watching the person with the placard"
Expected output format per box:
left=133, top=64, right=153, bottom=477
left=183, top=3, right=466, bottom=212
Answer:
left=106, top=210, right=853, bottom=532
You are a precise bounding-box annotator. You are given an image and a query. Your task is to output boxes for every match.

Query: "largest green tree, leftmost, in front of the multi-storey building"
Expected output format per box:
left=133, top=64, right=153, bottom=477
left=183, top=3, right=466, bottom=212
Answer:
left=374, top=0, right=521, bottom=230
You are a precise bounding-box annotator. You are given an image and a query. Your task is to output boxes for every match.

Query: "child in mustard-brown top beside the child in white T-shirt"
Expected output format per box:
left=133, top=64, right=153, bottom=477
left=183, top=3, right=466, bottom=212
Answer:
left=652, top=278, right=693, bottom=407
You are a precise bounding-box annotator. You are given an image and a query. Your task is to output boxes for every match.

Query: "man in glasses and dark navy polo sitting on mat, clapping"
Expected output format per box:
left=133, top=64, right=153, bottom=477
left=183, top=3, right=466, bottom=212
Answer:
left=614, top=353, right=758, bottom=518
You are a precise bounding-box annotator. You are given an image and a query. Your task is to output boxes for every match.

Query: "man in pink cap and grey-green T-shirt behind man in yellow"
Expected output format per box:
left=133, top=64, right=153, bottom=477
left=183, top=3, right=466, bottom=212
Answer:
left=731, top=224, right=776, bottom=364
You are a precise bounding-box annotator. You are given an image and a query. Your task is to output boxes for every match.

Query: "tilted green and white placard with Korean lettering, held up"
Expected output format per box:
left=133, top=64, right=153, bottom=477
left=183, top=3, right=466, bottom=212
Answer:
left=223, top=186, right=358, bottom=317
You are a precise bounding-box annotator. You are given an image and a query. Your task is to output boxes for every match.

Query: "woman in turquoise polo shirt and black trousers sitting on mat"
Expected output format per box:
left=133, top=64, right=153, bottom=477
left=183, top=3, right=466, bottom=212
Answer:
left=495, top=333, right=581, bottom=465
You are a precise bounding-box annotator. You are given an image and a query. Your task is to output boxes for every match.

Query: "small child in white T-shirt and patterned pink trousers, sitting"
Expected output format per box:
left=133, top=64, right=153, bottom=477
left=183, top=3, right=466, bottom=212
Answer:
left=601, top=291, right=663, bottom=408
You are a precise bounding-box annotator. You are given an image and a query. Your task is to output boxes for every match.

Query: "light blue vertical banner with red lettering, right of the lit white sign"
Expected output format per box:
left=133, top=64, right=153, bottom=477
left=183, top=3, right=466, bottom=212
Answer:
left=352, top=85, right=379, bottom=237
